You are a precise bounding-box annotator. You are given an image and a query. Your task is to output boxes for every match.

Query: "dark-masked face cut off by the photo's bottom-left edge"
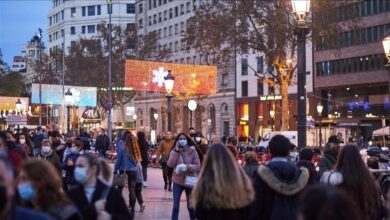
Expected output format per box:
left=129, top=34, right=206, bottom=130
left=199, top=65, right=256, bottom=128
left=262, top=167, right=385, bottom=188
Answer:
left=0, top=161, right=15, bottom=217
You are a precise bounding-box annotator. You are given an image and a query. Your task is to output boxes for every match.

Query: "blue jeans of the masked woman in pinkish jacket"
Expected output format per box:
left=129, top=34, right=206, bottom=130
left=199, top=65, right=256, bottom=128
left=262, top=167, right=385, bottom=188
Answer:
left=172, top=183, right=195, bottom=220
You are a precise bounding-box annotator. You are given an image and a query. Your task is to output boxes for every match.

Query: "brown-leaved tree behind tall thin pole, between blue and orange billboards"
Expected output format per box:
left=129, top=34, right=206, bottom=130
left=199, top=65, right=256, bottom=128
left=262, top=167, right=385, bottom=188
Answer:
left=66, top=23, right=169, bottom=126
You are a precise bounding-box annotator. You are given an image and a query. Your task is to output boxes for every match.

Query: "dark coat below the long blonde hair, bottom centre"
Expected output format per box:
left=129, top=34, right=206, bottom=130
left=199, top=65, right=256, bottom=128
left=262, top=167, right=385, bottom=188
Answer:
left=195, top=204, right=250, bottom=220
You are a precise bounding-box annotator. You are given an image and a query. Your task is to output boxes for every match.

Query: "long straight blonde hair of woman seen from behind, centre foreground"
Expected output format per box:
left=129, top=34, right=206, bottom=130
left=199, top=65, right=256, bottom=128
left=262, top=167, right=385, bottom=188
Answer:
left=191, top=144, right=254, bottom=209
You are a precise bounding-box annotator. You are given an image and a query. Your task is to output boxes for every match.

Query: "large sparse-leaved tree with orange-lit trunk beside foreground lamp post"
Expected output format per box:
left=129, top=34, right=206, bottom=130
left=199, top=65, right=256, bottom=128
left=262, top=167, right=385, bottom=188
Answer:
left=185, top=0, right=354, bottom=130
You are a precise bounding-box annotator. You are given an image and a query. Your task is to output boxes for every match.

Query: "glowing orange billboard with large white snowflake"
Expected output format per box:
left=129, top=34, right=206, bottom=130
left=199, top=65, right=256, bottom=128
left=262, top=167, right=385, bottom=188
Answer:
left=125, top=60, right=217, bottom=95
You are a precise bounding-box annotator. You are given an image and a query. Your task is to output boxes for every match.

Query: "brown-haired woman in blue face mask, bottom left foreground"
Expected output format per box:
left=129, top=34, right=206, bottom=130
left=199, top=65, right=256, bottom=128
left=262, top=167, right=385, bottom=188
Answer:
left=17, top=159, right=82, bottom=220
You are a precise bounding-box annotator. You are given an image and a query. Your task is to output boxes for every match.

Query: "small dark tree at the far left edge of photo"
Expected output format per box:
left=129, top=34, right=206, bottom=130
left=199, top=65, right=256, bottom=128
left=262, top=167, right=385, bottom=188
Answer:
left=0, top=72, right=26, bottom=96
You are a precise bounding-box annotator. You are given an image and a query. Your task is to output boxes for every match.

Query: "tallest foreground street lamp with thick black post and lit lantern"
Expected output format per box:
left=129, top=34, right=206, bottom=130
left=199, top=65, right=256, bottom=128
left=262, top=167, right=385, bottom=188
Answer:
left=291, top=0, right=310, bottom=147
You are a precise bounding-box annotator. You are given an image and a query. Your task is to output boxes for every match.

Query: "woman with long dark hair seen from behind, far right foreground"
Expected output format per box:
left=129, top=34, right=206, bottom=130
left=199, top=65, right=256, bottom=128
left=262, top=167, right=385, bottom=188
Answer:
left=326, top=145, right=383, bottom=220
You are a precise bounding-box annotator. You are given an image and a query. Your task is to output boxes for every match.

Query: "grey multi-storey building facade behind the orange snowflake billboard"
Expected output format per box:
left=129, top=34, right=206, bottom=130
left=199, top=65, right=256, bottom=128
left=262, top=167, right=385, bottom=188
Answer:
left=135, top=0, right=236, bottom=141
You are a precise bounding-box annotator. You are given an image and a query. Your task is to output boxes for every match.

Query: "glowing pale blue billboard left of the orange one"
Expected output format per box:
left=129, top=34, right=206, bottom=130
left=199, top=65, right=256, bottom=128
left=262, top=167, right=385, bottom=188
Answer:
left=31, top=84, right=97, bottom=107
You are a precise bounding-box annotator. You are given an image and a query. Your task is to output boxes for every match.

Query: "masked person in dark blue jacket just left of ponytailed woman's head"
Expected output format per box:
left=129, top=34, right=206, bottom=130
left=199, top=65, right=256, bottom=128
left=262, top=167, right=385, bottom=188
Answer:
left=61, top=141, right=79, bottom=191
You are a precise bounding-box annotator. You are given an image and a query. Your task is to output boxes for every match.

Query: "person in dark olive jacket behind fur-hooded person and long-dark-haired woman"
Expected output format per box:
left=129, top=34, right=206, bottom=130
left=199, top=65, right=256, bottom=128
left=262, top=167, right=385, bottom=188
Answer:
left=318, top=135, right=340, bottom=174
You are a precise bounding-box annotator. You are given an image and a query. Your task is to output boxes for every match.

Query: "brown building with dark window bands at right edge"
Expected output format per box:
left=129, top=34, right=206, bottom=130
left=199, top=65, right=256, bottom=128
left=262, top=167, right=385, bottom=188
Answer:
left=311, top=0, right=390, bottom=144
